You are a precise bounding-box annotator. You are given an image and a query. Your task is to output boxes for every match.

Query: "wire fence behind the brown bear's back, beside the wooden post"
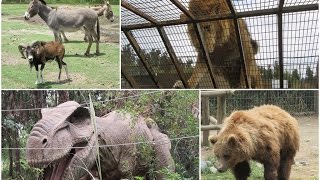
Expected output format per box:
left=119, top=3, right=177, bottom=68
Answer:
left=210, top=90, right=319, bottom=119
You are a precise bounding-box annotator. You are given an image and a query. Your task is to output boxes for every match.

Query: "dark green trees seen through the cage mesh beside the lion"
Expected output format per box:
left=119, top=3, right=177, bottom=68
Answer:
left=121, top=44, right=319, bottom=89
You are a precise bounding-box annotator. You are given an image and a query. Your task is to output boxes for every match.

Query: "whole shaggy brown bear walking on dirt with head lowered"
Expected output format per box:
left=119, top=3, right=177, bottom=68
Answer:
left=209, top=105, right=299, bottom=180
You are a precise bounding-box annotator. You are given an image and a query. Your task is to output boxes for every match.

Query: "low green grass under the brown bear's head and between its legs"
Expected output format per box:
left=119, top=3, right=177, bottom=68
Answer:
left=201, top=157, right=264, bottom=180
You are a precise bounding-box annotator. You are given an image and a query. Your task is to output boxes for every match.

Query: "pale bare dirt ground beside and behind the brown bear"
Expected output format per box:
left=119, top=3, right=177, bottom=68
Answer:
left=201, top=116, right=319, bottom=180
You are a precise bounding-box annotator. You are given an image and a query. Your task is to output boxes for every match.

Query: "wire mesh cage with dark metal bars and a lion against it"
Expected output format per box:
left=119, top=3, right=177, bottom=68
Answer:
left=121, top=0, right=319, bottom=89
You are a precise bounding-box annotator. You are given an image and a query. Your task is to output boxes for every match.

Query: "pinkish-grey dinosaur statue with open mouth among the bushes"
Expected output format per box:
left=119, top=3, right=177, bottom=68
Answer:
left=26, top=101, right=174, bottom=180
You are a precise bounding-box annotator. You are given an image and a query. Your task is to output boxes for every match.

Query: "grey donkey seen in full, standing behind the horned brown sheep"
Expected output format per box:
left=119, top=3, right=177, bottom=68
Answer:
left=24, top=0, right=100, bottom=56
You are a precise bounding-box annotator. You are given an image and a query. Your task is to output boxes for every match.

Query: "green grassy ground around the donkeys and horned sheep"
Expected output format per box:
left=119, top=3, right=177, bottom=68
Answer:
left=2, top=4, right=120, bottom=89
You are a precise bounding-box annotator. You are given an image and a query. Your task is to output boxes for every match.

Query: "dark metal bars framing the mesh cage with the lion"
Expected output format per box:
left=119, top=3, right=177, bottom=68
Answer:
left=121, top=0, right=319, bottom=88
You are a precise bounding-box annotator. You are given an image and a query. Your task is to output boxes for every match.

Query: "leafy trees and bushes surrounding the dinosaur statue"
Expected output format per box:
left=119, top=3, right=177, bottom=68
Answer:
left=2, top=90, right=199, bottom=179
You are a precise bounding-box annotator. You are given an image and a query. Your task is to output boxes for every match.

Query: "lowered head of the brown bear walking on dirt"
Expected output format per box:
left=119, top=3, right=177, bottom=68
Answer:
left=209, top=133, right=250, bottom=172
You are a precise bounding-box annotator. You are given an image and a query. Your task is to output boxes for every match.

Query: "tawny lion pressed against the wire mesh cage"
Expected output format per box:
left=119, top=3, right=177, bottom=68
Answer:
left=174, top=0, right=262, bottom=89
